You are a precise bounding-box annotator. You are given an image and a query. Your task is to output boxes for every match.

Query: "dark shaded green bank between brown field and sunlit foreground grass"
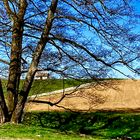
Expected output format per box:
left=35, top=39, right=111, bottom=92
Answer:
left=23, top=112, right=140, bottom=139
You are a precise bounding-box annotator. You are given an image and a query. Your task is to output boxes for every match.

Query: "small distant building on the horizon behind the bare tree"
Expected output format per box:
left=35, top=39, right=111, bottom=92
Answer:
left=35, top=71, right=50, bottom=80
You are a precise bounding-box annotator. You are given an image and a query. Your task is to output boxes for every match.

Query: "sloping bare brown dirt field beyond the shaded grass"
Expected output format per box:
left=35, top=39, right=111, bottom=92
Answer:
left=26, top=80, right=140, bottom=112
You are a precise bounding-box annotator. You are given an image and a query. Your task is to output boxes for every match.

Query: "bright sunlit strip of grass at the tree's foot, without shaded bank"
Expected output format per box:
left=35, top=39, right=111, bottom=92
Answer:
left=0, top=124, right=98, bottom=140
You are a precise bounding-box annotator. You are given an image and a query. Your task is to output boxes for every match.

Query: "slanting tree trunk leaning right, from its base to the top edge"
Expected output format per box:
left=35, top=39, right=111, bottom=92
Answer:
left=11, top=0, right=58, bottom=123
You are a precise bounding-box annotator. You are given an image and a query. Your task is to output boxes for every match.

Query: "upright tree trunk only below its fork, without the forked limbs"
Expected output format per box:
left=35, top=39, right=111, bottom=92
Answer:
left=7, top=20, right=23, bottom=113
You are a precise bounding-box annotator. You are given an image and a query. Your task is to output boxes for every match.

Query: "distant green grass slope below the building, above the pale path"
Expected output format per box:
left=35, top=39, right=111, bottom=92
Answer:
left=2, top=79, right=92, bottom=95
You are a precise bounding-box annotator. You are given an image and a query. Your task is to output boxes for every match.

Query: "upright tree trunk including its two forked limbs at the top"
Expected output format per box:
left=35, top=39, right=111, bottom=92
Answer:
left=4, top=0, right=27, bottom=115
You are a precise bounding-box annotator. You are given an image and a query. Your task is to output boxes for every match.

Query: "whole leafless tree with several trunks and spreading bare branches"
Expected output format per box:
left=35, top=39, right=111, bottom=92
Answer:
left=0, top=0, right=139, bottom=123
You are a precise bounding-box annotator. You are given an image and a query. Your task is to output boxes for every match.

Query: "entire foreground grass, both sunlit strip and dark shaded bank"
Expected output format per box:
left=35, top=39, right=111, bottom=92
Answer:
left=0, top=112, right=140, bottom=140
